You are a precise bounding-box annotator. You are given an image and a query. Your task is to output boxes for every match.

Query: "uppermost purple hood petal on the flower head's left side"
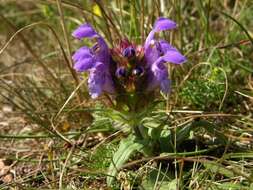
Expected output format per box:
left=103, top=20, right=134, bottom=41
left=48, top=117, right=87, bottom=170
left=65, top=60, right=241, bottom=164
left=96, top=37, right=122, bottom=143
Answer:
left=72, top=24, right=98, bottom=40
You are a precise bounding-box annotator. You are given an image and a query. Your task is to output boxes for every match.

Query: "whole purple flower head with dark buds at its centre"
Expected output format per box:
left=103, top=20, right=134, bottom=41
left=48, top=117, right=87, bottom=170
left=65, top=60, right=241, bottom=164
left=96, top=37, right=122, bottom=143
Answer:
left=72, top=18, right=186, bottom=98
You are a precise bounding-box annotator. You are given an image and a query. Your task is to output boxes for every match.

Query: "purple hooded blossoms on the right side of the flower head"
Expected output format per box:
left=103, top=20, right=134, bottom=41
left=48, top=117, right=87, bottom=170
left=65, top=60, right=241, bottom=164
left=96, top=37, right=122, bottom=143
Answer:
left=144, top=18, right=186, bottom=94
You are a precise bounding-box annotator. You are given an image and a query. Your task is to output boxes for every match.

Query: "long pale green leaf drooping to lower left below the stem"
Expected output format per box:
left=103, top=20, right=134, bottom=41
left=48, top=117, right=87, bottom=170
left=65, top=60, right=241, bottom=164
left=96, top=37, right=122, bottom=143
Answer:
left=107, top=135, right=145, bottom=186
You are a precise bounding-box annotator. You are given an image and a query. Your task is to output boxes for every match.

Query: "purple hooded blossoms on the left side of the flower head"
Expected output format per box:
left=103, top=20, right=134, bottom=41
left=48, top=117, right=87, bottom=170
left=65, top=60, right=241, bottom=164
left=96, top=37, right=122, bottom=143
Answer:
left=72, top=24, right=114, bottom=98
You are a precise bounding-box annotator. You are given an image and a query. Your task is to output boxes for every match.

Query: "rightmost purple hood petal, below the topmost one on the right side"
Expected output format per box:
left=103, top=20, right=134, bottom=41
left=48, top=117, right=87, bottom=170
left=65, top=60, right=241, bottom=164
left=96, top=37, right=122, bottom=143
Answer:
left=162, top=49, right=186, bottom=64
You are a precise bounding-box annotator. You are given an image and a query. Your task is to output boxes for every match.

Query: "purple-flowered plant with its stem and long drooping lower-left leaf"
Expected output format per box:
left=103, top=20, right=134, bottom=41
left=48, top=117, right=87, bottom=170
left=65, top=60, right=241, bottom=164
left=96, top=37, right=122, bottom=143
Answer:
left=72, top=18, right=186, bottom=185
